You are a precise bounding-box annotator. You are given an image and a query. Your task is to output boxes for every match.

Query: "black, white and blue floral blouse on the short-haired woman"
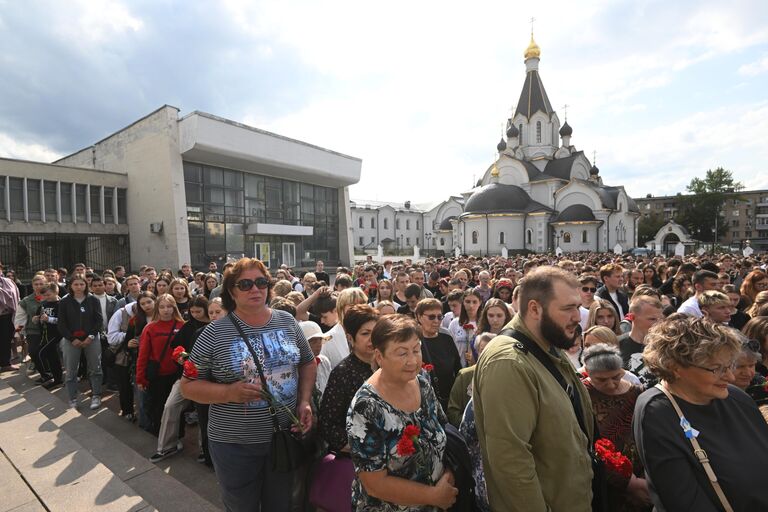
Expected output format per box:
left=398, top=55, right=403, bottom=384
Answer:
left=347, top=374, right=448, bottom=512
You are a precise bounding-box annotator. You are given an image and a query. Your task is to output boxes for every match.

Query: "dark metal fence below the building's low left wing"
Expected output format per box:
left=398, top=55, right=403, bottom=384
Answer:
left=0, top=233, right=131, bottom=281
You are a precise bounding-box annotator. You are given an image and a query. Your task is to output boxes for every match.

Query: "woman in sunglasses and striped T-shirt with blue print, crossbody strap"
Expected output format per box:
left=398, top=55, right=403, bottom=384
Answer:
left=181, top=258, right=317, bottom=512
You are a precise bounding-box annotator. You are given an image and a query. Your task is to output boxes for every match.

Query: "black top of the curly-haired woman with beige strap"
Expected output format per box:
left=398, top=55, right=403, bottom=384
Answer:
left=633, top=386, right=768, bottom=512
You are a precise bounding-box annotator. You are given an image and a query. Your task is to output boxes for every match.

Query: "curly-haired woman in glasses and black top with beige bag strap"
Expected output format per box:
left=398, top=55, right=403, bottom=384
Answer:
left=633, top=315, right=768, bottom=512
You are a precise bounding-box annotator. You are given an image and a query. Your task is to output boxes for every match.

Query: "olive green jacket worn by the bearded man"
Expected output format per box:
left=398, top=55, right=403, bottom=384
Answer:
left=472, top=315, right=594, bottom=512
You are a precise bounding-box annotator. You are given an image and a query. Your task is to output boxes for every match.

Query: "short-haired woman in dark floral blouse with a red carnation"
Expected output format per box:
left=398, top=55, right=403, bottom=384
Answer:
left=347, top=316, right=458, bottom=512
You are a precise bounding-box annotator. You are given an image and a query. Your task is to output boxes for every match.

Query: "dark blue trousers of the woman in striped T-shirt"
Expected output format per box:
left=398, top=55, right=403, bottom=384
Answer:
left=208, top=440, right=293, bottom=512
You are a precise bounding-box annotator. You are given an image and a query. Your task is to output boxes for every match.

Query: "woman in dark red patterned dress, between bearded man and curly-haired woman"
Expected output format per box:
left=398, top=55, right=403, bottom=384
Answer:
left=582, top=343, right=651, bottom=511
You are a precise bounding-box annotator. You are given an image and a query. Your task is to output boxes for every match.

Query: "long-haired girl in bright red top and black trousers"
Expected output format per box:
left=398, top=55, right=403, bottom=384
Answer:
left=136, top=294, right=184, bottom=435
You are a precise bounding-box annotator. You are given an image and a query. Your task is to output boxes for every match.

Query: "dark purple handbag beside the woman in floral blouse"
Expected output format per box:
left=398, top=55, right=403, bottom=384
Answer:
left=309, top=453, right=355, bottom=512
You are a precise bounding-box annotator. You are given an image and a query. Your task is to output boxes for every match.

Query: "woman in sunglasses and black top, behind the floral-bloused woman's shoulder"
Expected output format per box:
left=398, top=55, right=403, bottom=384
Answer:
left=415, top=299, right=461, bottom=411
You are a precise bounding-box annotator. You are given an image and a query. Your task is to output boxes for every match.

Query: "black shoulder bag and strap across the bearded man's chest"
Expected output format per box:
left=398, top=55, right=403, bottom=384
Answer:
left=499, top=329, right=608, bottom=512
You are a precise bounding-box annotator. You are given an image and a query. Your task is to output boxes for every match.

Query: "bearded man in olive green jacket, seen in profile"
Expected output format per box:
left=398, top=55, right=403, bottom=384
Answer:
left=472, top=267, right=594, bottom=512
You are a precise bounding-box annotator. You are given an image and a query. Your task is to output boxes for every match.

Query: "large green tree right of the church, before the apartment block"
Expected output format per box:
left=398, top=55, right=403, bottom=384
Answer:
left=677, top=167, right=744, bottom=242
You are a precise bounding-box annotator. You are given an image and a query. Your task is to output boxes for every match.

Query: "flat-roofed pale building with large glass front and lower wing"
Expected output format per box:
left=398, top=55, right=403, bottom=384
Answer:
left=0, top=105, right=362, bottom=276
